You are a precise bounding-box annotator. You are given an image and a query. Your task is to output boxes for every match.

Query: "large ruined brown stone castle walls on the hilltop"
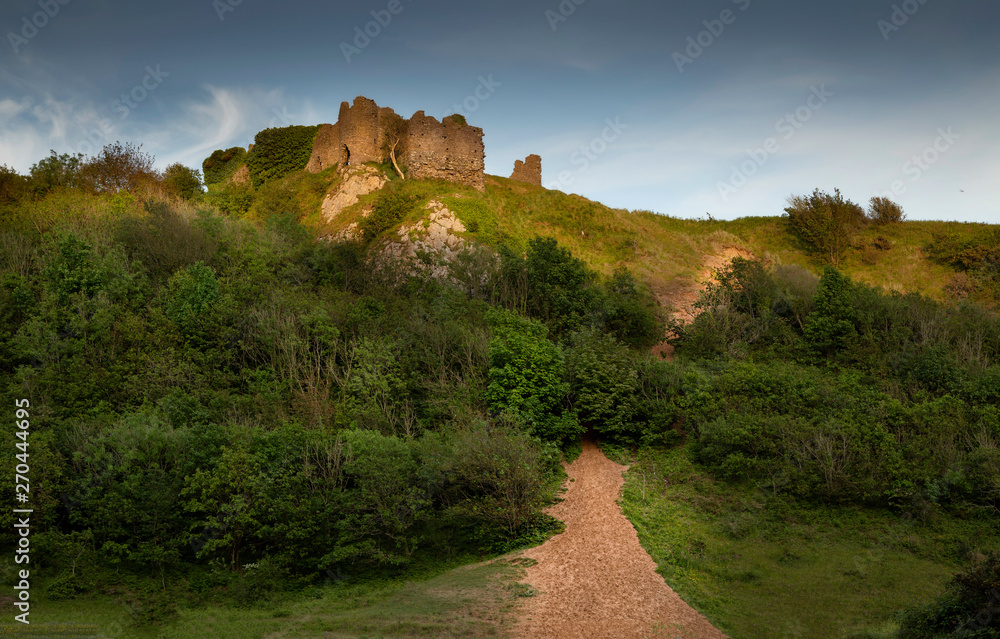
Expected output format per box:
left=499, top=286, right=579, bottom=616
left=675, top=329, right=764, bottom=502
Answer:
left=306, top=96, right=488, bottom=191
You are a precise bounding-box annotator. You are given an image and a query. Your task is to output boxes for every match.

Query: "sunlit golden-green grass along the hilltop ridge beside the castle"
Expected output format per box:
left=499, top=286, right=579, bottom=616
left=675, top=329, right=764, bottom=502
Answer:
left=310, top=170, right=984, bottom=310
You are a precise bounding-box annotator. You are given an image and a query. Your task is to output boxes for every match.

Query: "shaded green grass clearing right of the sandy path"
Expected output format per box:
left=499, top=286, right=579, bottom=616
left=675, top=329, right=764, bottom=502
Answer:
left=620, top=448, right=1000, bottom=639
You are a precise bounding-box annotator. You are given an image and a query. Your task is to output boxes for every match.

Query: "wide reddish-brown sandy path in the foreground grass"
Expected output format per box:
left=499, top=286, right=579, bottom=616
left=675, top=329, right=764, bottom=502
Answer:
left=512, top=440, right=725, bottom=639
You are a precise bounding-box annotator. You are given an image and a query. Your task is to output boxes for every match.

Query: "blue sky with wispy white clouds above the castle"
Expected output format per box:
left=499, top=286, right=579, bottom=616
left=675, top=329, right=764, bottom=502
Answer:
left=0, top=0, right=1000, bottom=223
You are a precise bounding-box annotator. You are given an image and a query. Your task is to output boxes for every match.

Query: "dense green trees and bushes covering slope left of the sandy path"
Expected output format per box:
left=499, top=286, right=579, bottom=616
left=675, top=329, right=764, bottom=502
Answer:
left=0, top=184, right=656, bottom=601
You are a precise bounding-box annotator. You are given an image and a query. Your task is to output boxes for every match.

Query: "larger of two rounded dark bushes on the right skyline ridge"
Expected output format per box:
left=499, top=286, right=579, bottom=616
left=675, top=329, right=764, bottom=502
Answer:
left=785, top=189, right=866, bottom=266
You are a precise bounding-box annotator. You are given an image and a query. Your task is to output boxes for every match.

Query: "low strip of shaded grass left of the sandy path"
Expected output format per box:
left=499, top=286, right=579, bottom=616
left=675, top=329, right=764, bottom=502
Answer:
left=15, top=558, right=534, bottom=639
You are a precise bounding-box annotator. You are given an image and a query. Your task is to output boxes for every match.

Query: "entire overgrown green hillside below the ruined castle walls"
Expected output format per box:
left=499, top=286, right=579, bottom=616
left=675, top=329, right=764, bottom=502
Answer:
left=0, top=141, right=1000, bottom=639
